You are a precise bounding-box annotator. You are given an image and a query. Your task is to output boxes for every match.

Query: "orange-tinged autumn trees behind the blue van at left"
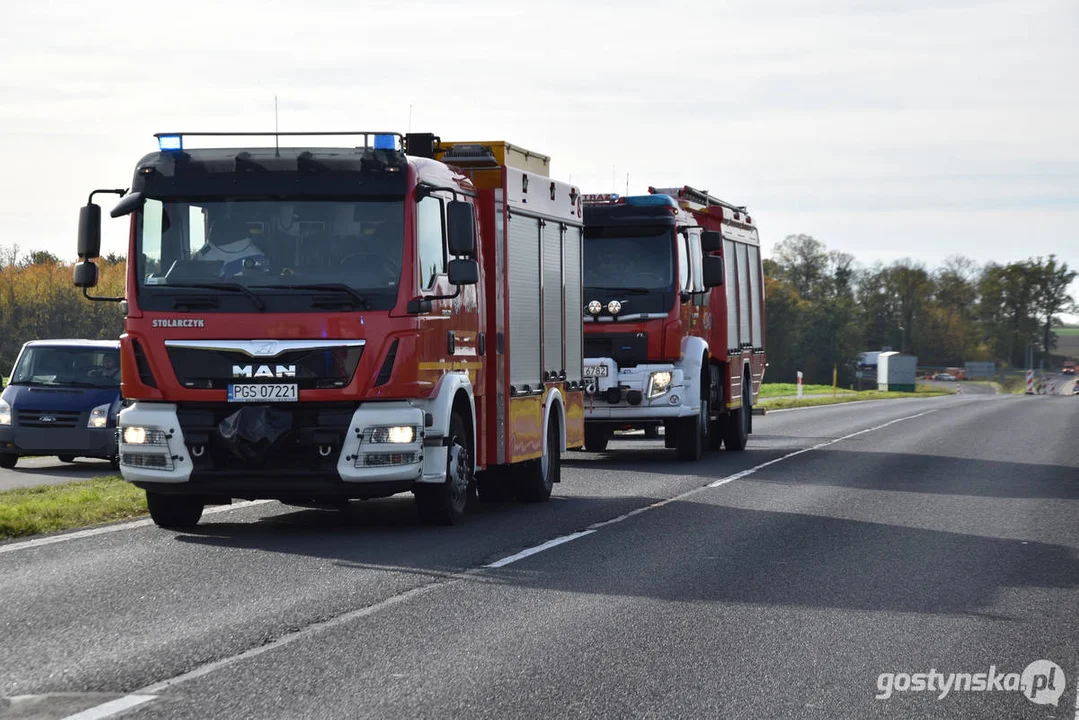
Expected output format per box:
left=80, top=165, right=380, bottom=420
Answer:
left=0, top=247, right=125, bottom=376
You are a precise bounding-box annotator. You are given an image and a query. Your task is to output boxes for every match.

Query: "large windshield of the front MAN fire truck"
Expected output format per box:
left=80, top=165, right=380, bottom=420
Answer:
left=136, top=198, right=405, bottom=293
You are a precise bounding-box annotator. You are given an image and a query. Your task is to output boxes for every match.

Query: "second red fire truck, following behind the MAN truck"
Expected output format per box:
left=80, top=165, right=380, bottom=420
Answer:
left=584, top=187, right=765, bottom=460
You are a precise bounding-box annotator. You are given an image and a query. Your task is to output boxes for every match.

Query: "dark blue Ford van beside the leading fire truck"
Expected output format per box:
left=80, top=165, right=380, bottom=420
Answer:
left=0, top=340, right=121, bottom=468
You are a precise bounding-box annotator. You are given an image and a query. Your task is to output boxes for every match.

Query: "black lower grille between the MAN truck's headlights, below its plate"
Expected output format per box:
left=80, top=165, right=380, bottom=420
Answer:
left=177, top=403, right=356, bottom=475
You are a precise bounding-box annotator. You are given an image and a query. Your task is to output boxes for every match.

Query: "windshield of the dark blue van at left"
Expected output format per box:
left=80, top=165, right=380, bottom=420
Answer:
left=11, top=345, right=120, bottom=388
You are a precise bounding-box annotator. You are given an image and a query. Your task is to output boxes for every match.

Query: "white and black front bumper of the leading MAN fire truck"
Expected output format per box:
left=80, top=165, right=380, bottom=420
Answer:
left=118, top=402, right=433, bottom=498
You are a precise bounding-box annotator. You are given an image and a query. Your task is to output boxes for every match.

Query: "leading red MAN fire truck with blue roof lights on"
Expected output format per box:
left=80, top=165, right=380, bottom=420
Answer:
left=74, top=133, right=585, bottom=527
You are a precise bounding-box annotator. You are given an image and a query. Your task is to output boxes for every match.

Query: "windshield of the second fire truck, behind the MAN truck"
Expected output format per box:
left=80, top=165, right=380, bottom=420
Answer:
left=585, top=227, right=674, bottom=290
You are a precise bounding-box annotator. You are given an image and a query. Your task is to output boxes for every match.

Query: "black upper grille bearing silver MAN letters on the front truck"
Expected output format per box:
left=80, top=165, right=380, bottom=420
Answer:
left=167, top=347, right=364, bottom=390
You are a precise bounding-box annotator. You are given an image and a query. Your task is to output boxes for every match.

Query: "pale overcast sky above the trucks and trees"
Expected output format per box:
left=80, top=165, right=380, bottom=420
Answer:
left=0, top=0, right=1079, bottom=315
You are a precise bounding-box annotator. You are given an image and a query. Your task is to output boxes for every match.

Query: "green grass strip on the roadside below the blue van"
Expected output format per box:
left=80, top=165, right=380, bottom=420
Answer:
left=0, top=475, right=147, bottom=540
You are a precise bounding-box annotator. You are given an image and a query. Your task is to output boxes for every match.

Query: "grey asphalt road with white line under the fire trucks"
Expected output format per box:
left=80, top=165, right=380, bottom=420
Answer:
left=0, top=394, right=1079, bottom=720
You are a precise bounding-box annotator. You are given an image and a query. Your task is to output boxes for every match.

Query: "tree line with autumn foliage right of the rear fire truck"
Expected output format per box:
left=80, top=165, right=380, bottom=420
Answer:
left=764, top=234, right=1076, bottom=384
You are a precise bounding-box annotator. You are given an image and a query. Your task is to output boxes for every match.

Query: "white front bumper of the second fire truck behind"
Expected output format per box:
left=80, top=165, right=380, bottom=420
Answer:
left=585, top=357, right=700, bottom=422
